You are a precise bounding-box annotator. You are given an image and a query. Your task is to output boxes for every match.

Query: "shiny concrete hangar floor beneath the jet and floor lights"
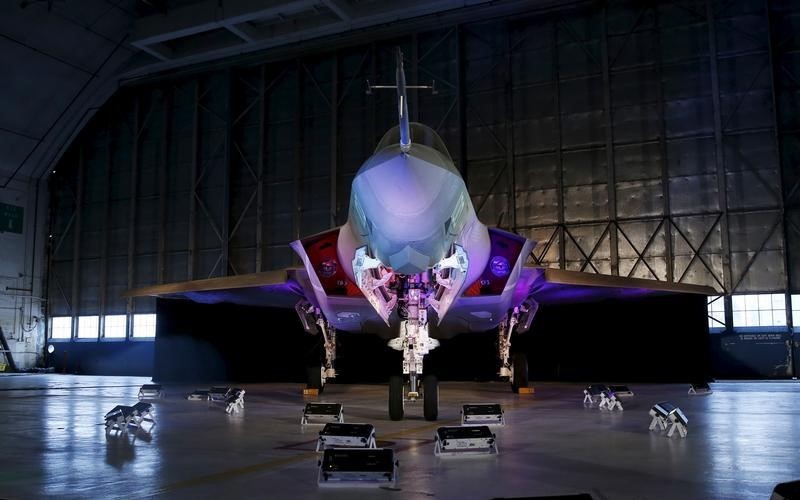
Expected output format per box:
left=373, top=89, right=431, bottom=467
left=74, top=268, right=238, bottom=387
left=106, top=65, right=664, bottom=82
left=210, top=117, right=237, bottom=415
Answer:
left=0, top=375, right=800, bottom=499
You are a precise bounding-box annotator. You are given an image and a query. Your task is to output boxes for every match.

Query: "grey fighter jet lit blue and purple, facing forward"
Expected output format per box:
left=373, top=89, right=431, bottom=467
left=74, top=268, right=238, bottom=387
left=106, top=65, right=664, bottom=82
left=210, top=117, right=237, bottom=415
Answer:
left=125, top=50, right=713, bottom=420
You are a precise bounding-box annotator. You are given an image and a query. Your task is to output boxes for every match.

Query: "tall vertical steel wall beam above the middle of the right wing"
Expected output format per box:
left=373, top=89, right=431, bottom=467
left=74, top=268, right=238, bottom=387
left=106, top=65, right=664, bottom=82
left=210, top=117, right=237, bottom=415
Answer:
left=600, top=6, right=619, bottom=276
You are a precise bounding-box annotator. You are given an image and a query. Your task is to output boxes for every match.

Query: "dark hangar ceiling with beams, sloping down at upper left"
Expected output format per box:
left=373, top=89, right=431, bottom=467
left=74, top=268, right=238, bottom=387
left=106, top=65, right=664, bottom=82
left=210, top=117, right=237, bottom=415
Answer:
left=0, top=0, right=573, bottom=187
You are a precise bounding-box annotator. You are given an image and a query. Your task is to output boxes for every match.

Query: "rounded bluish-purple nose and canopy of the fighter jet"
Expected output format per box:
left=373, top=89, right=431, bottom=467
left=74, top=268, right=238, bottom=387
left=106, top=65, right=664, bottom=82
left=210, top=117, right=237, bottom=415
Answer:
left=349, top=123, right=474, bottom=274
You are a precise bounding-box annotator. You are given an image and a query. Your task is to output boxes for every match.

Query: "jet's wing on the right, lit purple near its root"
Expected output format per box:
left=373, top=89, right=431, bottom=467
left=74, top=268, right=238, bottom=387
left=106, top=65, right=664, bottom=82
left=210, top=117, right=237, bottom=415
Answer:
left=513, top=267, right=717, bottom=304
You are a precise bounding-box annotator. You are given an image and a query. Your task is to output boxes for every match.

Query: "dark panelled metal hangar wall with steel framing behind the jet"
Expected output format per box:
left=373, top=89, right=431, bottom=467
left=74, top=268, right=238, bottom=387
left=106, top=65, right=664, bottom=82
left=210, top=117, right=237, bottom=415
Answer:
left=48, top=0, right=800, bottom=315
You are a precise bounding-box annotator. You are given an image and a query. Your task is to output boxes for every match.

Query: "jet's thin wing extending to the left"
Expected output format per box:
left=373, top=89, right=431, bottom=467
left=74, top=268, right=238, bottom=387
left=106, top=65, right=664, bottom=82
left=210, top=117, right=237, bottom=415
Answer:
left=123, top=268, right=315, bottom=308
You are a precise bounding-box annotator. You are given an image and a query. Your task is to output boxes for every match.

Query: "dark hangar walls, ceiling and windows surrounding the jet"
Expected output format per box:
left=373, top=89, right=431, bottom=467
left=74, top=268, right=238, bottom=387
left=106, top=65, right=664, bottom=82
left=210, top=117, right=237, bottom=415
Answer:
left=0, top=0, right=800, bottom=378
